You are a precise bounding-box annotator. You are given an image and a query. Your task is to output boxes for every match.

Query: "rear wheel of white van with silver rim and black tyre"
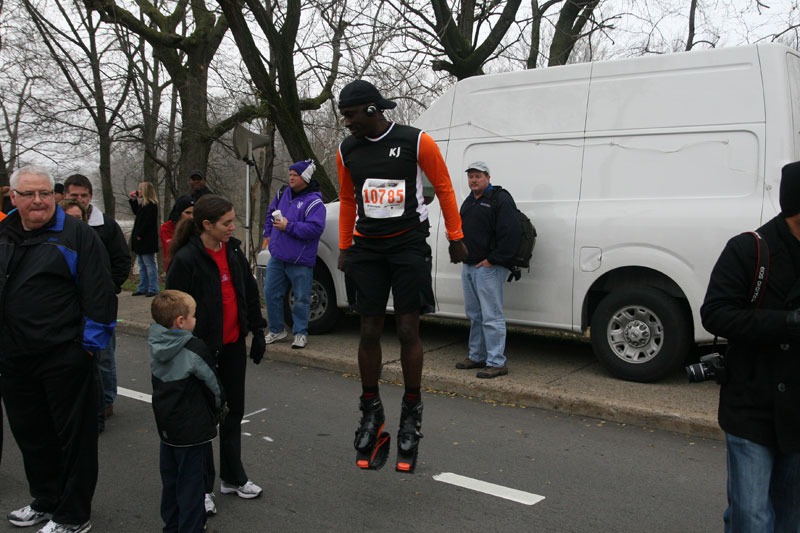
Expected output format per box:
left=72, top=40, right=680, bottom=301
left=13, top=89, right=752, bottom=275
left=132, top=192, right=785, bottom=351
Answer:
left=591, top=287, right=690, bottom=382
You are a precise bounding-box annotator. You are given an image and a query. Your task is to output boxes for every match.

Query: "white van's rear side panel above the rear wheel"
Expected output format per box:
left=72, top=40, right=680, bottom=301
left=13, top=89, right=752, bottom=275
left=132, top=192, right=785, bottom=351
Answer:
left=573, top=50, right=766, bottom=341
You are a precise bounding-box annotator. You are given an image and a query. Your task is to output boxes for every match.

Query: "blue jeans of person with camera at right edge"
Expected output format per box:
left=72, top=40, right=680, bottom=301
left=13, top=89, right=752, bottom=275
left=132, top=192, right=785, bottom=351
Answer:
left=723, top=433, right=800, bottom=533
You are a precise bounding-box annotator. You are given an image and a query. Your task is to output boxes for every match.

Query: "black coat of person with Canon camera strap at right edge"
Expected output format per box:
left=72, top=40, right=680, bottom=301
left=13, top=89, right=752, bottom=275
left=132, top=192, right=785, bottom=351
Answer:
left=700, top=216, right=800, bottom=453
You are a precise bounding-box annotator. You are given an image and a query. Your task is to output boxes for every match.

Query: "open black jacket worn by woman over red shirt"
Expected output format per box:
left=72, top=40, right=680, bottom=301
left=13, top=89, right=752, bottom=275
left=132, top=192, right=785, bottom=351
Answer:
left=166, top=235, right=267, bottom=353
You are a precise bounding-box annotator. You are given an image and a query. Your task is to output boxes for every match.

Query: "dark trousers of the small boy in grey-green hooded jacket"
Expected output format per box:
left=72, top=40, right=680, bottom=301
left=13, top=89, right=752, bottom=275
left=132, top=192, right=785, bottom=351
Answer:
left=159, top=442, right=211, bottom=533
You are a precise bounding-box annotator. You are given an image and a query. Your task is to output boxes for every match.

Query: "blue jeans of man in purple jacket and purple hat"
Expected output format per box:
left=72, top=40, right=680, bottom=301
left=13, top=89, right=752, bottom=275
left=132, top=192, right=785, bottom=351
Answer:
left=264, top=257, right=314, bottom=335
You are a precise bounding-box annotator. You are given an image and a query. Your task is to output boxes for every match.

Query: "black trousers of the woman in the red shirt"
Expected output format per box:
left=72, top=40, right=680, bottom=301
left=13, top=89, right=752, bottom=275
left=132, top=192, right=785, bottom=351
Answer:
left=206, top=336, right=247, bottom=492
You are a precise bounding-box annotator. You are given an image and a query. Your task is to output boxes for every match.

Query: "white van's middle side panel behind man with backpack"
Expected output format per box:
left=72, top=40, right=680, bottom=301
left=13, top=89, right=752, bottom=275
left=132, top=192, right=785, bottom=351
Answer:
left=428, top=65, right=591, bottom=329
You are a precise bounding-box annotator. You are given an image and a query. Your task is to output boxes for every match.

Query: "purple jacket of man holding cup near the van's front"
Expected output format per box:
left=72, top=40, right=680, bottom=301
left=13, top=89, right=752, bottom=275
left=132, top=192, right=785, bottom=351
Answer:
left=264, top=179, right=325, bottom=267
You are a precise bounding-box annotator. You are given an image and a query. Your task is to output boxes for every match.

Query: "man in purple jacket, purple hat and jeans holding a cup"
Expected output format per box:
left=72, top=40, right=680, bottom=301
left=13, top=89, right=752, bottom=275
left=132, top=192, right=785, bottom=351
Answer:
left=264, top=159, right=325, bottom=348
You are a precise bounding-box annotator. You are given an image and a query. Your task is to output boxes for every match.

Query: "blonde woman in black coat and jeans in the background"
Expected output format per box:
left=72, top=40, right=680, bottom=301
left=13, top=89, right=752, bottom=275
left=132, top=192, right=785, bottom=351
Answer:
left=129, top=181, right=158, bottom=297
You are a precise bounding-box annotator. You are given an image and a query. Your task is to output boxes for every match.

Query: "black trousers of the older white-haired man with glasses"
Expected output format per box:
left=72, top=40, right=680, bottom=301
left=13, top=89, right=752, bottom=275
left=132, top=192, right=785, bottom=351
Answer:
left=0, top=342, right=97, bottom=524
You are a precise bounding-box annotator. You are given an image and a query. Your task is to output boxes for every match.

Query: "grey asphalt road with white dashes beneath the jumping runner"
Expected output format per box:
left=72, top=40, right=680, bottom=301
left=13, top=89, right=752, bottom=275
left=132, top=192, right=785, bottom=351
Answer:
left=0, top=335, right=725, bottom=533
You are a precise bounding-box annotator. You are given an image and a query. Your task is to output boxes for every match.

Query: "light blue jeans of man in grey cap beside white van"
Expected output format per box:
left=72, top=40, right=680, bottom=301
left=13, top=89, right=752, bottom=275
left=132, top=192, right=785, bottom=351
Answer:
left=461, top=265, right=508, bottom=367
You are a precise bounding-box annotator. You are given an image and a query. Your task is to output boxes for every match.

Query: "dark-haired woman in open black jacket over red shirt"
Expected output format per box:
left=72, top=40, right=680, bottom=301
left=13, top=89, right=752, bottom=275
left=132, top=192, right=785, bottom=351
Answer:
left=166, top=194, right=267, bottom=514
